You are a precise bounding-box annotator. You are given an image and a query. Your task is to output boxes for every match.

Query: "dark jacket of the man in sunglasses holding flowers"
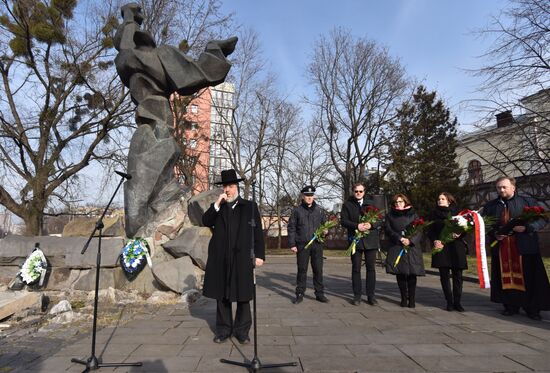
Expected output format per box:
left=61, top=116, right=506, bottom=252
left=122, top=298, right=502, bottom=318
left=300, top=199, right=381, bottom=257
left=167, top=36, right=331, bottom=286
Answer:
left=340, top=196, right=382, bottom=250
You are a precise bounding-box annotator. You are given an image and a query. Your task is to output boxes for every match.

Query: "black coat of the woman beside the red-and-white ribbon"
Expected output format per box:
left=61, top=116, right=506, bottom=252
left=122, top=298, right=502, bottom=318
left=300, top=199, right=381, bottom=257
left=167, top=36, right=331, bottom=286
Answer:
left=427, top=205, right=468, bottom=269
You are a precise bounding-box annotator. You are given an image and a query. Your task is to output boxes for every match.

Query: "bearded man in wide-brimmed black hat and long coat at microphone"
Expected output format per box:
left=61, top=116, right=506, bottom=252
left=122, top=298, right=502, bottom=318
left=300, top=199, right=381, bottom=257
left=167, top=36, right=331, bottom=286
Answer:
left=202, top=170, right=265, bottom=344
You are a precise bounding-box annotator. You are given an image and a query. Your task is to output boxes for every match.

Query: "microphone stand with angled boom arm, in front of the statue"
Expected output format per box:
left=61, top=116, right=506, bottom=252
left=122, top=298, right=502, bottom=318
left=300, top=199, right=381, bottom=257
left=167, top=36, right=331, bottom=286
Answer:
left=71, top=172, right=143, bottom=373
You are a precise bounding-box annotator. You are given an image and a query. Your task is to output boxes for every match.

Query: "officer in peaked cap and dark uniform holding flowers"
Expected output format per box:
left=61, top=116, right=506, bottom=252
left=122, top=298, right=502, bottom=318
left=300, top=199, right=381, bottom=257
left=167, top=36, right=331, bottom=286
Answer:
left=288, top=185, right=328, bottom=304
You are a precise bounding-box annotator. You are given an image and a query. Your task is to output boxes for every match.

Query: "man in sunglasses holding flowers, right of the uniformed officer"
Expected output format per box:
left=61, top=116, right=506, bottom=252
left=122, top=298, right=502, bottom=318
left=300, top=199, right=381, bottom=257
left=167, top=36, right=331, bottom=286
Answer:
left=340, top=183, right=382, bottom=306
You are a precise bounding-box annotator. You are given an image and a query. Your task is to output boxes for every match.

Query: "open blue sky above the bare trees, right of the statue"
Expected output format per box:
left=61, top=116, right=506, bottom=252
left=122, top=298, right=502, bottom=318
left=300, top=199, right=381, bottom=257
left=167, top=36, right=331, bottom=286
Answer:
left=220, top=0, right=507, bottom=130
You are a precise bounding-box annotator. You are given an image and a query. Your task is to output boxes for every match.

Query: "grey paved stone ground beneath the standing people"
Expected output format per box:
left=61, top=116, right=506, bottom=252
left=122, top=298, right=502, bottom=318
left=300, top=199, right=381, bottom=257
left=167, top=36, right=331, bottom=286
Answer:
left=0, top=257, right=550, bottom=372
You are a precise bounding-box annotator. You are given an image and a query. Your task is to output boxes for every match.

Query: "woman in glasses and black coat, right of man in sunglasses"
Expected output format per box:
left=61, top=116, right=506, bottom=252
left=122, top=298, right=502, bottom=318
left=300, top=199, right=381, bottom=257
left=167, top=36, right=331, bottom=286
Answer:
left=385, top=194, right=426, bottom=308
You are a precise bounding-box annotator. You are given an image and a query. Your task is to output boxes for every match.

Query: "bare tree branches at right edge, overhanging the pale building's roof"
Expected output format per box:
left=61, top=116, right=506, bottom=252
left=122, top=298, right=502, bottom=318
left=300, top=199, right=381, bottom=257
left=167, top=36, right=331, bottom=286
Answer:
left=463, top=0, right=550, bottom=199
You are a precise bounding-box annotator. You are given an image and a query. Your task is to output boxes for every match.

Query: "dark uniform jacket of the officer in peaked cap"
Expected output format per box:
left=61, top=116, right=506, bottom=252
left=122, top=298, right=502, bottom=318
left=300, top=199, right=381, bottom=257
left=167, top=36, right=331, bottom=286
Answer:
left=288, top=201, right=327, bottom=248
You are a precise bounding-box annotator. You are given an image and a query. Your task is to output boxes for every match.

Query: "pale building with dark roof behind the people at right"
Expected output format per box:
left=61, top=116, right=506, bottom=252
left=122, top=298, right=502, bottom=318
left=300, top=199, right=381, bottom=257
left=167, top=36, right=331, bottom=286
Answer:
left=456, top=89, right=550, bottom=206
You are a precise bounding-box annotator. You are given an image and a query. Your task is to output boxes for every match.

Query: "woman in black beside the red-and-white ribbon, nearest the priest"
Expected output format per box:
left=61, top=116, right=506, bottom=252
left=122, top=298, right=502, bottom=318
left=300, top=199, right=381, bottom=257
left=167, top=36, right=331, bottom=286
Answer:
left=428, top=192, right=468, bottom=312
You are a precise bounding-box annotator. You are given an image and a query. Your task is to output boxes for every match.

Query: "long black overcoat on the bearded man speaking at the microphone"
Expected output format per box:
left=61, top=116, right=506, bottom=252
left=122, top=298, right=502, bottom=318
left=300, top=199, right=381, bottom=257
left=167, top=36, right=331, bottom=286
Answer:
left=202, top=197, right=265, bottom=302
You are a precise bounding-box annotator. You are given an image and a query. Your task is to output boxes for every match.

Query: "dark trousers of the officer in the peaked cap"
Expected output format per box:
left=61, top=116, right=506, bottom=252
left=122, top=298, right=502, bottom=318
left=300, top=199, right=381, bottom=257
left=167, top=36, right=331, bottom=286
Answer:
left=296, top=243, right=325, bottom=295
